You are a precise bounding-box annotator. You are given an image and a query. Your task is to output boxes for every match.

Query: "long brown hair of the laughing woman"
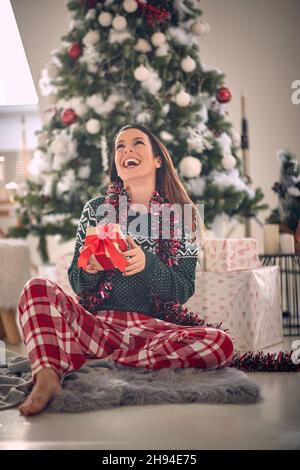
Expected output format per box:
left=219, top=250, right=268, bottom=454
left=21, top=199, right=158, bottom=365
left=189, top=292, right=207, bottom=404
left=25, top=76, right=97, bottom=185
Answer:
left=109, top=124, right=206, bottom=245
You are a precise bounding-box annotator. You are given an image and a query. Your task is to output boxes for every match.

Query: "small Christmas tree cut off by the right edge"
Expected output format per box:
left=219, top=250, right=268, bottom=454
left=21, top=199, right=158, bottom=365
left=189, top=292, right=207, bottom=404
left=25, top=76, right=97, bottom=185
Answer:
left=267, top=150, right=300, bottom=251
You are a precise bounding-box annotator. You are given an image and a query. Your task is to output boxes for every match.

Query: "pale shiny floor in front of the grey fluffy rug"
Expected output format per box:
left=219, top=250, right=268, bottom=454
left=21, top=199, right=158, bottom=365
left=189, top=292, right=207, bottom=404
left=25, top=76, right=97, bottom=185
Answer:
left=0, top=338, right=300, bottom=450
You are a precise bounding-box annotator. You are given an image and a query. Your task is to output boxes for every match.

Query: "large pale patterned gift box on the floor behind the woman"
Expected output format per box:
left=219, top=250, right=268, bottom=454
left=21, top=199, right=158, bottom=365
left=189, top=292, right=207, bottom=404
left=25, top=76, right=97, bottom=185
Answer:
left=185, top=266, right=283, bottom=351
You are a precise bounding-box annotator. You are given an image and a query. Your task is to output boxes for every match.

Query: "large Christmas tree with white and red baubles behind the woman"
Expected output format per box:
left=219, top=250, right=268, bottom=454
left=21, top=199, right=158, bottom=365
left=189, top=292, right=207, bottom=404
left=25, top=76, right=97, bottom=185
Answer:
left=9, top=0, right=265, bottom=261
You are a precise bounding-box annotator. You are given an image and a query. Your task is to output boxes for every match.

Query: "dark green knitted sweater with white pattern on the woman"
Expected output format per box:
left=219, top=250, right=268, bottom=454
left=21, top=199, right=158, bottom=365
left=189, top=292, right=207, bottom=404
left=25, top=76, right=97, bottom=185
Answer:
left=68, top=196, right=198, bottom=316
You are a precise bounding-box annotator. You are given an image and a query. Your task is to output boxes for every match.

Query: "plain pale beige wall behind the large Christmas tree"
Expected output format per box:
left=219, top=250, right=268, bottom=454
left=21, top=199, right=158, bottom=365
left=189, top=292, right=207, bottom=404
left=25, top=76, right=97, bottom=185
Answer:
left=0, top=0, right=300, bottom=262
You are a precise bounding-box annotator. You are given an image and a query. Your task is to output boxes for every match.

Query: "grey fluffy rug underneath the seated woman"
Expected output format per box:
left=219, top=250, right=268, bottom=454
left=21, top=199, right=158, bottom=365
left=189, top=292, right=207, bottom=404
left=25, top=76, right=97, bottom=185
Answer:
left=0, top=350, right=262, bottom=413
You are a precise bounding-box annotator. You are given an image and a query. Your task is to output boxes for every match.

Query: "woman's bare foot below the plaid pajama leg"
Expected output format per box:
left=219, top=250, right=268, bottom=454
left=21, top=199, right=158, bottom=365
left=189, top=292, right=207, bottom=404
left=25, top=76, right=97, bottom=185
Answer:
left=19, top=368, right=62, bottom=416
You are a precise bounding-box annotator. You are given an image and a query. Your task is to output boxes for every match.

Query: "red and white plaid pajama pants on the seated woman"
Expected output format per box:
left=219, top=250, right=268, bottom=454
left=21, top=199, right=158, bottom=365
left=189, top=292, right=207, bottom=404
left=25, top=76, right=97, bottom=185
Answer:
left=18, top=278, right=233, bottom=380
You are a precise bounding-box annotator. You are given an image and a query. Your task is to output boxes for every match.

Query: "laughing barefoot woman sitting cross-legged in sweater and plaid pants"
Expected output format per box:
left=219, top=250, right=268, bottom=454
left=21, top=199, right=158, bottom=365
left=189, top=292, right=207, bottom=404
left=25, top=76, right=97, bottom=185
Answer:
left=19, top=125, right=233, bottom=415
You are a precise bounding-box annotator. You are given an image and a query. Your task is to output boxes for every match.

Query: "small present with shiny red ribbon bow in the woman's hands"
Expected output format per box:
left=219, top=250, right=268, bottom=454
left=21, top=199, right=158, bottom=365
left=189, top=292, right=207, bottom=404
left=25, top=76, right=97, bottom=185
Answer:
left=77, top=223, right=129, bottom=272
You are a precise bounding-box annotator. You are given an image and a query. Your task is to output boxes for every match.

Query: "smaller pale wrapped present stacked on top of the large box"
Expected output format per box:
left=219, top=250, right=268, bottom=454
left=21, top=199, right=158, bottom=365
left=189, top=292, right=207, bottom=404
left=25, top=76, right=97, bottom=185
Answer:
left=204, top=238, right=261, bottom=273
